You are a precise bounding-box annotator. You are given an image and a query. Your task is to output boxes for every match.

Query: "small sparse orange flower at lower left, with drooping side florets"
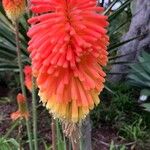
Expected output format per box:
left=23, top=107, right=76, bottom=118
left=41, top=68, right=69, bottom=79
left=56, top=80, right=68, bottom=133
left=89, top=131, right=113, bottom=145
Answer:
left=11, top=93, right=29, bottom=121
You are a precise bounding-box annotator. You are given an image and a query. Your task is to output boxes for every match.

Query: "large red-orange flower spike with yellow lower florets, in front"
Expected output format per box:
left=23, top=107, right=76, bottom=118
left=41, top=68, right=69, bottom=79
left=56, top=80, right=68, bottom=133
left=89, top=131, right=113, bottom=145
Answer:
left=28, top=0, right=109, bottom=123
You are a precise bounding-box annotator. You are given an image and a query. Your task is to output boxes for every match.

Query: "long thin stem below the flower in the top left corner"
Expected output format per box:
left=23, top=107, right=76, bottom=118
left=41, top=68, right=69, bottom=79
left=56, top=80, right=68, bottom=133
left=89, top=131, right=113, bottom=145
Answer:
left=15, top=21, right=33, bottom=150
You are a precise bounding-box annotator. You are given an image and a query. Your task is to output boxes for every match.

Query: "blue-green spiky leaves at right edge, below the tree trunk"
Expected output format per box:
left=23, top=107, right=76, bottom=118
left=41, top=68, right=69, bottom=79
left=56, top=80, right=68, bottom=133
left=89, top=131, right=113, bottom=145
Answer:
left=128, top=51, right=150, bottom=111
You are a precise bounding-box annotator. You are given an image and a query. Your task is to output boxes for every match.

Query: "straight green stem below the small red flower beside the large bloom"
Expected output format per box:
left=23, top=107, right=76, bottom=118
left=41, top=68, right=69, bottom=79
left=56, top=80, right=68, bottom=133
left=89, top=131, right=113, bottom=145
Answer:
left=32, top=76, right=38, bottom=150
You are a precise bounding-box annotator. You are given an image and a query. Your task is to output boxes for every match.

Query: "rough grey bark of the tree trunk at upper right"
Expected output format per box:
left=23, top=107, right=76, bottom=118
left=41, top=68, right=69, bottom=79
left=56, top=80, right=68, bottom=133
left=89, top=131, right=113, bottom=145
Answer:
left=109, top=0, right=150, bottom=82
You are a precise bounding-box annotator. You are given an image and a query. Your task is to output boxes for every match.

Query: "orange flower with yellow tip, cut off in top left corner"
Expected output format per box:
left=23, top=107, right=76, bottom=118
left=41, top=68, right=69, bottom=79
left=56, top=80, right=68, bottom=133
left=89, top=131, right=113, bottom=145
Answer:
left=2, top=0, right=26, bottom=22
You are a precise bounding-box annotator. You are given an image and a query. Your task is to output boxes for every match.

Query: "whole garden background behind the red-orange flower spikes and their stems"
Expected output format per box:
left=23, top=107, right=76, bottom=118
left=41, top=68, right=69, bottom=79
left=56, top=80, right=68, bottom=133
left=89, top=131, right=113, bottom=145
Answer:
left=0, top=0, right=150, bottom=150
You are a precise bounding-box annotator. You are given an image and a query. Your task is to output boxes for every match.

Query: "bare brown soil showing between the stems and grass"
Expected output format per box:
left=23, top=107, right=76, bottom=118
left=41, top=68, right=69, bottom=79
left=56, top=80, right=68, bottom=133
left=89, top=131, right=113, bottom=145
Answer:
left=0, top=86, right=134, bottom=150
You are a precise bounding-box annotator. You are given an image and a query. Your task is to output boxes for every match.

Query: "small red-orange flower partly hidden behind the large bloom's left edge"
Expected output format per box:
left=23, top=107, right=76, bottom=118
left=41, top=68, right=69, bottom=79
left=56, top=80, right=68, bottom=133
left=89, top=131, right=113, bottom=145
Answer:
left=24, top=65, right=32, bottom=91
